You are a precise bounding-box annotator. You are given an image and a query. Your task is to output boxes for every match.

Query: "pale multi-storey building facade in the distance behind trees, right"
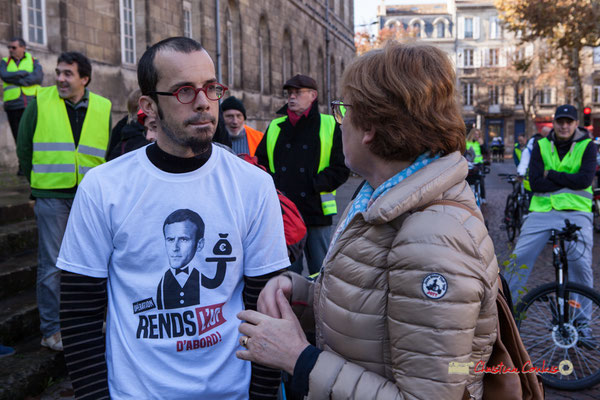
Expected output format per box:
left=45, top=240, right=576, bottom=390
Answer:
left=378, top=0, right=600, bottom=151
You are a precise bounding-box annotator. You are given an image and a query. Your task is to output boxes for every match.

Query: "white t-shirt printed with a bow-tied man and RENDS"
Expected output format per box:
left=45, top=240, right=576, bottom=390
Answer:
left=57, top=146, right=289, bottom=399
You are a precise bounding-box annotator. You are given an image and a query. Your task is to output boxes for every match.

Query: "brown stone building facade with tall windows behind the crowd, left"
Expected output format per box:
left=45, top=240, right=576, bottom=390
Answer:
left=0, top=0, right=355, bottom=167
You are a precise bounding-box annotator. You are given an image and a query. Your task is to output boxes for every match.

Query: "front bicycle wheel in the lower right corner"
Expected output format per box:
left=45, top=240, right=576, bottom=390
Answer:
left=516, top=282, right=600, bottom=390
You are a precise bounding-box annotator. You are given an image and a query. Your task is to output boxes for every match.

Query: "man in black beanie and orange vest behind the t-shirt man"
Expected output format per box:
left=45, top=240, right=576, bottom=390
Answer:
left=221, top=96, right=264, bottom=157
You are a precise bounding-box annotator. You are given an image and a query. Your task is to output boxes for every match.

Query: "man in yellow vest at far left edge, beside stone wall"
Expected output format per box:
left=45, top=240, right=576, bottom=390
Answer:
left=0, top=37, right=44, bottom=143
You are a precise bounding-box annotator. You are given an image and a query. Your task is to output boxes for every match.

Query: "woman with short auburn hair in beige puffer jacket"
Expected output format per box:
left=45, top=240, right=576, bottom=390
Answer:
left=238, top=44, right=498, bottom=400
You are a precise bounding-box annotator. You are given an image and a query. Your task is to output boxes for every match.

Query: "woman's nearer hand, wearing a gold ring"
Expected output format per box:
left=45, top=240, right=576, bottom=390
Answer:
left=235, top=290, right=310, bottom=375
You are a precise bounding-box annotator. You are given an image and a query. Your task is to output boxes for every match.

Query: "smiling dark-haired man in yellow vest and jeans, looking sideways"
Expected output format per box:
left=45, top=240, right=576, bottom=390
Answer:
left=17, top=52, right=111, bottom=351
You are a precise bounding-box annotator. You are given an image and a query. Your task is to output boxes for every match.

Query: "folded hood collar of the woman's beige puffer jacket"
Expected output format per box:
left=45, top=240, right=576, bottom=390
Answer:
left=364, top=151, right=469, bottom=224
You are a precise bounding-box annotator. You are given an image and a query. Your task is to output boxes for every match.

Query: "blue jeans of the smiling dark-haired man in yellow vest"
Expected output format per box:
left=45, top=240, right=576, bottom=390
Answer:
left=33, top=198, right=73, bottom=337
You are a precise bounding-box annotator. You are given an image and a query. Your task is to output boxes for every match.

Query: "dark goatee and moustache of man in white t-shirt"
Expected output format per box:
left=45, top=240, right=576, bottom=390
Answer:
left=158, top=106, right=217, bottom=155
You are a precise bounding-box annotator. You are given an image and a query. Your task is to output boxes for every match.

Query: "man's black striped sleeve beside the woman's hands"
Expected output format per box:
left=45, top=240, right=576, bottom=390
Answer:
left=243, top=269, right=285, bottom=400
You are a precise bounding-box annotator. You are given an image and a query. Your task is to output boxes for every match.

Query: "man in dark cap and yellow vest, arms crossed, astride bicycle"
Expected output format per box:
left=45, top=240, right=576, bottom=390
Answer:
left=507, top=104, right=597, bottom=345
